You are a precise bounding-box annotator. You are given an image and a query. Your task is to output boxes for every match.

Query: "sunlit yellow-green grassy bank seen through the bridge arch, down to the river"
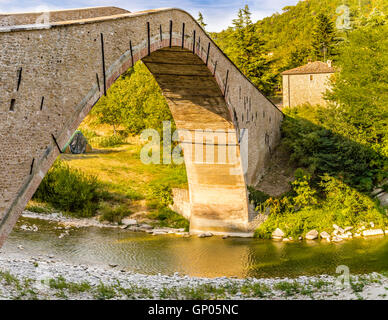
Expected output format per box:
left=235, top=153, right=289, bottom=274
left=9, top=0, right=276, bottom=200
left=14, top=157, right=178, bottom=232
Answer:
left=27, top=120, right=188, bottom=229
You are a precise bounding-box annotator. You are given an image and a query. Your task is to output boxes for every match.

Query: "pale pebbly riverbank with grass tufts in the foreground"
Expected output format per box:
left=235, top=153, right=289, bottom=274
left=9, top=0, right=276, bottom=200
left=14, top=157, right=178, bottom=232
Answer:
left=0, top=253, right=388, bottom=300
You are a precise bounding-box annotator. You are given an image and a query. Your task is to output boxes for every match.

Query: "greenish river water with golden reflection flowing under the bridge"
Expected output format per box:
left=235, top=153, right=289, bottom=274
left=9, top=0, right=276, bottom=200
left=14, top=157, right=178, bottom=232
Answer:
left=1, top=218, right=388, bottom=278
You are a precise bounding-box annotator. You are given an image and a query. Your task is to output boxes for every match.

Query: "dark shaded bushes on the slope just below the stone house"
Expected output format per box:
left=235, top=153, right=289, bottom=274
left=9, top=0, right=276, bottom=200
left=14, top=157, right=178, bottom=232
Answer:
left=282, top=105, right=388, bottom=191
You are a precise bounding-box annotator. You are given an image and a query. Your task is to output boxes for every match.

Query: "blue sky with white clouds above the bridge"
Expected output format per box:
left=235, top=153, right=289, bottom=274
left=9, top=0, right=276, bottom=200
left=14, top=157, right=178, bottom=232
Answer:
left=0, top=0, right=299, bottom=32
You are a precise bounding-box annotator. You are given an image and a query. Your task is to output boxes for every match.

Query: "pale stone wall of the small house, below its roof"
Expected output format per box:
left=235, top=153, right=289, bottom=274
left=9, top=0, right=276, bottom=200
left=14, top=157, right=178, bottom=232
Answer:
left=283, top=73, right=332, bottom=107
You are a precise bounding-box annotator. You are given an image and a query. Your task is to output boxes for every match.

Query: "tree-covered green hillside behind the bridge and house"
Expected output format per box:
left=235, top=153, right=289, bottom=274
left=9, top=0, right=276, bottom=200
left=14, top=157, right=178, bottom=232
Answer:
left=211, top=0, right=388, bottom=95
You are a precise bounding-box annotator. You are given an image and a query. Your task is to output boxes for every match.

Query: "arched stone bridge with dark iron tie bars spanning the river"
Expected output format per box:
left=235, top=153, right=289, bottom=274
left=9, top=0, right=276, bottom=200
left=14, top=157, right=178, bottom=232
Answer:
left=0, top=7, right=283, bottom=245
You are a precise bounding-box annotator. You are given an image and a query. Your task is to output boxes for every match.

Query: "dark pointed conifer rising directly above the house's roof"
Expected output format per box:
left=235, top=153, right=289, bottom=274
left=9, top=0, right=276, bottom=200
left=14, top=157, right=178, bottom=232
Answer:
left=312, top=13, right=336, bottom=61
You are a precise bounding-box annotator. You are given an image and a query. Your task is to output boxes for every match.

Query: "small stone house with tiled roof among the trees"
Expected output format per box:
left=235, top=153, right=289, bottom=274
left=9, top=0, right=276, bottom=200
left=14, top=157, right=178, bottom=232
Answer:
left=282, top=60, right=335, bottom=107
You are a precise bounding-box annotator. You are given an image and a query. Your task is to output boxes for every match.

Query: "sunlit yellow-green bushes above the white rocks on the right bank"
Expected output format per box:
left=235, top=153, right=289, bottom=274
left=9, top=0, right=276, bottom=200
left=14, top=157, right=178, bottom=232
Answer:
left=255, top=175, right=388, bottom=239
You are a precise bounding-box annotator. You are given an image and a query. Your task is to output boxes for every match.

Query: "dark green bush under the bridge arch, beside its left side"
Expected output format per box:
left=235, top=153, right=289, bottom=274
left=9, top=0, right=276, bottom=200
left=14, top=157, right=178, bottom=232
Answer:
left=33, top=159, right=100, bottom=217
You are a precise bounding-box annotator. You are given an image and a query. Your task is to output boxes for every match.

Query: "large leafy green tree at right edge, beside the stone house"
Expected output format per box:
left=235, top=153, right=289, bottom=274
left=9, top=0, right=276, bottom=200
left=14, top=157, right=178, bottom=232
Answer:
left=326, top=16, right=388, bottom=157
